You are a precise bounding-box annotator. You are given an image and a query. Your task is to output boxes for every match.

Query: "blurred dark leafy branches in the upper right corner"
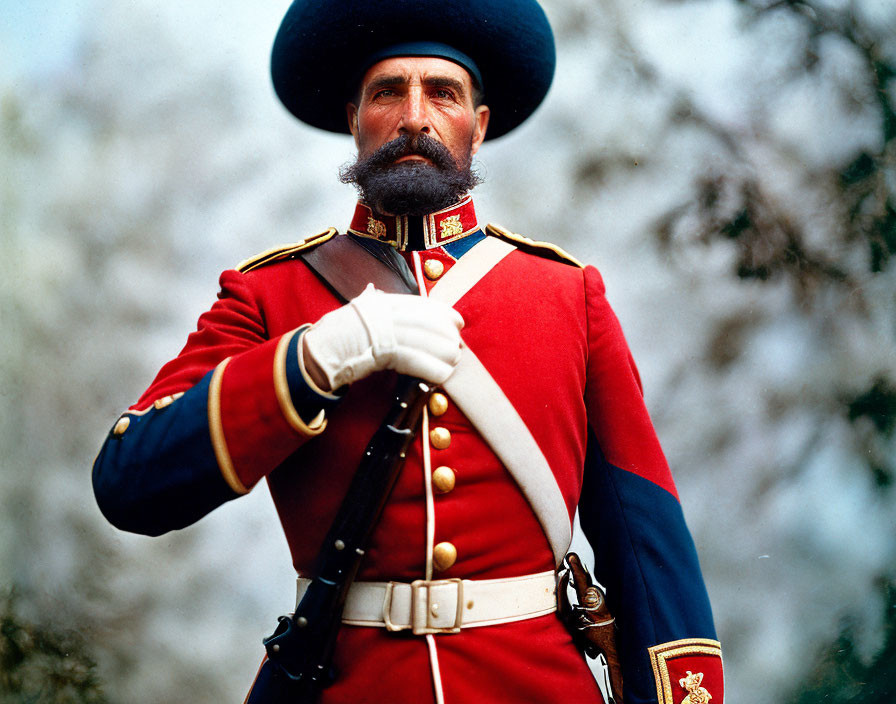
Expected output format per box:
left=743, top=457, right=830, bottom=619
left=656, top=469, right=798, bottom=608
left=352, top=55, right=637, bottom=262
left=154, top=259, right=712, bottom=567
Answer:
left=657, top=0, right=896, bottom=288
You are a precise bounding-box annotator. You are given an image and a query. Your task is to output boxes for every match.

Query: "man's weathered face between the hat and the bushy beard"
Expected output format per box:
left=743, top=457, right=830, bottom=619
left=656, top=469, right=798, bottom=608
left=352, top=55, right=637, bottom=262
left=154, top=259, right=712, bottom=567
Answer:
left=346, top=56, right=489, bottom=167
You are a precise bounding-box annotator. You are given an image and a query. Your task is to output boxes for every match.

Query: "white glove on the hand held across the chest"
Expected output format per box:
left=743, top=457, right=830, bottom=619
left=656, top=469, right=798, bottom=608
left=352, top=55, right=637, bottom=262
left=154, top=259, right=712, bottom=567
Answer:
left=304, top=284, right=464, bottom=389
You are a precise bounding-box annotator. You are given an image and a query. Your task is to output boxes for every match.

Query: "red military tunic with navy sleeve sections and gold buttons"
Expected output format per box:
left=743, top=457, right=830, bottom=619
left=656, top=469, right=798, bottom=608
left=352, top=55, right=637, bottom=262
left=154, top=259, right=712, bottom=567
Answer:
left=95, top=201, right=723, bottom=704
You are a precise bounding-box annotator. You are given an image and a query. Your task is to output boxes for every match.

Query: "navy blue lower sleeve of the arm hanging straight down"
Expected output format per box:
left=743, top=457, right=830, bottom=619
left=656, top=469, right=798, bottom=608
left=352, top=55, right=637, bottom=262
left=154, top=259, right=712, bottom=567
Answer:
left=579, top=432, right=716, bottom=704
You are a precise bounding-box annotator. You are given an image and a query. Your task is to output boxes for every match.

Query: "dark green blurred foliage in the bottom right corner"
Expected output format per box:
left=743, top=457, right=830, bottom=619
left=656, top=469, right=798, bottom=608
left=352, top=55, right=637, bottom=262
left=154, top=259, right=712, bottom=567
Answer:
left=788, top=581, right=896, bottom=704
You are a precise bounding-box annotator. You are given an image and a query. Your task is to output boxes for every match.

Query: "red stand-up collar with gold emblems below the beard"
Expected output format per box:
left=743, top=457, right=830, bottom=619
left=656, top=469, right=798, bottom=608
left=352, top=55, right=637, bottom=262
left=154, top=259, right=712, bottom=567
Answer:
left=348, top=196, right=479, bottom=250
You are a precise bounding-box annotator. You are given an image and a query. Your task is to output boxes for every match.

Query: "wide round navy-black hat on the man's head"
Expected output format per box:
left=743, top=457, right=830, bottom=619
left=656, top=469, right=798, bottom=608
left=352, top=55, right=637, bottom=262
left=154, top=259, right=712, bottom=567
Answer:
left=271, top=0, right=556, bottom=139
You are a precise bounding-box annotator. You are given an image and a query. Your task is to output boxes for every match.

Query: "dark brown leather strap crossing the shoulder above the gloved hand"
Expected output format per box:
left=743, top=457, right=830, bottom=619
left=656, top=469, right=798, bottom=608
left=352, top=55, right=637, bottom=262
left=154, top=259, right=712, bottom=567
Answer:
left=299, top=235, right=418, bottom=301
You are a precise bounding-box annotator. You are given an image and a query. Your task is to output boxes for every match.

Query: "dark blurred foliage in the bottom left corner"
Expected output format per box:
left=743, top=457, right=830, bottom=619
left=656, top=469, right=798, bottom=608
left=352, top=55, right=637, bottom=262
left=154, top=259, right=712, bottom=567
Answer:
left=0, top=590, right=108, bottom=704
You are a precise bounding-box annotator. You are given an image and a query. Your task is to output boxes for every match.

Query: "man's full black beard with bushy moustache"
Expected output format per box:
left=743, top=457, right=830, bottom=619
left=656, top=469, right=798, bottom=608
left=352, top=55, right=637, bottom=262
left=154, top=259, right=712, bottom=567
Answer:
left=339, top=133, right=480, bottom=215
